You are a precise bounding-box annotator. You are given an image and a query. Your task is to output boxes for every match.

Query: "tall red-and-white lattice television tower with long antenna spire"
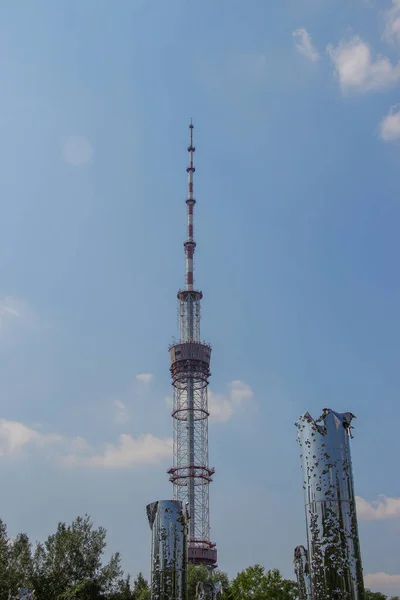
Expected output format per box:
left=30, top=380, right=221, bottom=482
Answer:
left=168, top=122, right=217, bottom=568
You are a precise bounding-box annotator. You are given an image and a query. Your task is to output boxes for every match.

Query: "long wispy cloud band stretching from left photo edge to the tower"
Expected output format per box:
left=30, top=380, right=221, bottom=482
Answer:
left=0, top=419, right=172, bottom=469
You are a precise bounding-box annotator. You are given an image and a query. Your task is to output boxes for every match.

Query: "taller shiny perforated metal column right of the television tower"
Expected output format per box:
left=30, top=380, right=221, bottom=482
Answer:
left=296, top=409, right=364, bottom=600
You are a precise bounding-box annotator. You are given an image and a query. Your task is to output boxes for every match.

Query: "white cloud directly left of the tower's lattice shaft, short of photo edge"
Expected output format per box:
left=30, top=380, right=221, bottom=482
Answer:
left=62, top=433, right=173, bottom=469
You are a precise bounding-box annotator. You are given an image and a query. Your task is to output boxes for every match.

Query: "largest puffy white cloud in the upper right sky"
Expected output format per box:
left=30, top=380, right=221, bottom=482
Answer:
left=327, top=36, right=400, bottom=92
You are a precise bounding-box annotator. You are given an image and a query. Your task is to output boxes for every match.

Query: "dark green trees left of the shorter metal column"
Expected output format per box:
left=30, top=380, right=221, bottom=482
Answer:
left=0, top=515, right=134, bottom=600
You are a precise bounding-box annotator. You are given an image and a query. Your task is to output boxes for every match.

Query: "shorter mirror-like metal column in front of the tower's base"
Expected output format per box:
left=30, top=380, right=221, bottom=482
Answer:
left=146, top=500, right=188, bottom=600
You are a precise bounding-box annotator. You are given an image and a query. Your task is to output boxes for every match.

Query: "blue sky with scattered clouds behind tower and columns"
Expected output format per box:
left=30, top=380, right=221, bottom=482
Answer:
left=0, top=0, right=400, bottom=593
